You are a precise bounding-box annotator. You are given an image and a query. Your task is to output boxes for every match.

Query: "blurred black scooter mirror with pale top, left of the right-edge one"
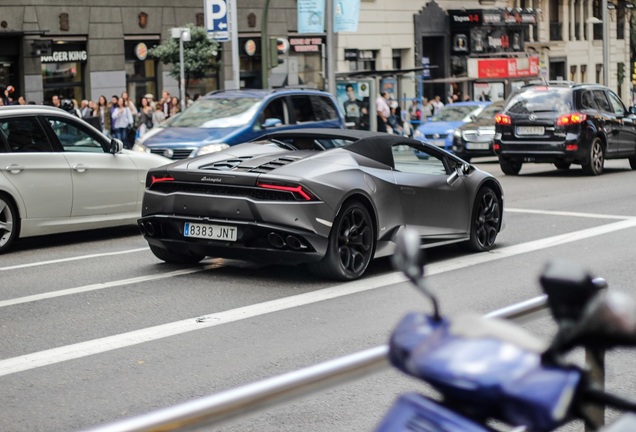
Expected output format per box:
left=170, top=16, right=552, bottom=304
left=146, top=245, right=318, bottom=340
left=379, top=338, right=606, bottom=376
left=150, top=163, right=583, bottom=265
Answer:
left=539, top=258, right=607, bottom=324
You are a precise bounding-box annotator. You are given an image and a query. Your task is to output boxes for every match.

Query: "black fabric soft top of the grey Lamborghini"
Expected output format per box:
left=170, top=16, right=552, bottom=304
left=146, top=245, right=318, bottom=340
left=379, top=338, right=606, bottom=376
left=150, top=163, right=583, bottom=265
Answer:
left=258, top=128, right=422, bottom=168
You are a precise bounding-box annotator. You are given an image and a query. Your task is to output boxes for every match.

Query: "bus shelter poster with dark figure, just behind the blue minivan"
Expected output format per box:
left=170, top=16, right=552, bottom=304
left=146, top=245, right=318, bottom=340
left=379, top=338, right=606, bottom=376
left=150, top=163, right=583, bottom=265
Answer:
left=336, top=80, right=371, bottom=130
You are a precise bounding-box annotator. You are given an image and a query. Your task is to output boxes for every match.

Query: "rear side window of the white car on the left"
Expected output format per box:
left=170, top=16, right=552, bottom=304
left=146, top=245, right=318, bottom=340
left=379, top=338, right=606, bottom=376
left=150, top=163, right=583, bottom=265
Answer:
left=0, top=117, right=53, bottom=153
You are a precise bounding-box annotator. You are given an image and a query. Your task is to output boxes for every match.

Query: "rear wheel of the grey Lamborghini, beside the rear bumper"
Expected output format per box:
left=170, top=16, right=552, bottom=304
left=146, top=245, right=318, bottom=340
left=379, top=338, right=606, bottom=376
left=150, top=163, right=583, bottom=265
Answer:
left=307, top=200, right=375, bottom=281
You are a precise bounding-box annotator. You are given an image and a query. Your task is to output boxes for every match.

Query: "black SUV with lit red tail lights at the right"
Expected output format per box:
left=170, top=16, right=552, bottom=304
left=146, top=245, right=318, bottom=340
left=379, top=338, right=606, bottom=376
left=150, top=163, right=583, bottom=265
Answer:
left=493, top=81, right=636, bottom=175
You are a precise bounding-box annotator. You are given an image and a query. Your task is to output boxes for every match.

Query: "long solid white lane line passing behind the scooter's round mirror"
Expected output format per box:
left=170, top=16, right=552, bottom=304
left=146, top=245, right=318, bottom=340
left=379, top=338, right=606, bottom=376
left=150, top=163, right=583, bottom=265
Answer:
left=0, top=218, right=636, bottom=376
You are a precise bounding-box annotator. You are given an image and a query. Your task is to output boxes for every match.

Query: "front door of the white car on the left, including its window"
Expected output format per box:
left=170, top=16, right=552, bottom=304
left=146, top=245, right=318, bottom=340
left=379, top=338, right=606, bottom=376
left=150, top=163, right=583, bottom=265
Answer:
left=48, top=116, right=140, bottom=217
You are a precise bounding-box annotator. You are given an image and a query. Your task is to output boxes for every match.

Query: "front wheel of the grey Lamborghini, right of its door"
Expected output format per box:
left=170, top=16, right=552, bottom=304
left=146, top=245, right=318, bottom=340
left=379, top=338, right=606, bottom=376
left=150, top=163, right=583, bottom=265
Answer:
left=468, top=186, right=502, bottom=252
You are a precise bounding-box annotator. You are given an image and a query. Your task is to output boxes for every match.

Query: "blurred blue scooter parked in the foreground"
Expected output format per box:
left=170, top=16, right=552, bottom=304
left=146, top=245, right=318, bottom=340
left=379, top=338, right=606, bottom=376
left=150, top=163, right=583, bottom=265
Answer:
left=376, top=230, right=636, bottom=432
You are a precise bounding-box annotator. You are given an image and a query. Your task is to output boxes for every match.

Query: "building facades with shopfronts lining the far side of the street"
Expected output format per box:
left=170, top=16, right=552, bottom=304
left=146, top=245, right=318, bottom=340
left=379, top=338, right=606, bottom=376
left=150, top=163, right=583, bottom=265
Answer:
left=0, top=0, right=632, bottom=107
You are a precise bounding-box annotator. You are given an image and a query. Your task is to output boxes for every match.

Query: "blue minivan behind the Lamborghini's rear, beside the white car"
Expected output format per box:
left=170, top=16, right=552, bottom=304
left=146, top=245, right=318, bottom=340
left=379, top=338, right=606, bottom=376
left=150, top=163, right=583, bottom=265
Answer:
left=133, top=88, right=345, bottom=159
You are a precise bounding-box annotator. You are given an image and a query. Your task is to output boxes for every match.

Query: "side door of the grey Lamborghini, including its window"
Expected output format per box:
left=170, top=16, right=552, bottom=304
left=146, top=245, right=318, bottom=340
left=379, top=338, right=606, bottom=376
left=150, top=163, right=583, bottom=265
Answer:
left=393, top=146, right=470, bottom=240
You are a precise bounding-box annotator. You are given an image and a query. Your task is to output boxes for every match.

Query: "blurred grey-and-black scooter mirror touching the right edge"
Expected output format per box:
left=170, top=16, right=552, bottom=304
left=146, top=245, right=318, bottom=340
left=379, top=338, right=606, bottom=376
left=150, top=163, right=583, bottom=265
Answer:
left=563, top=291, right=636, bottom=349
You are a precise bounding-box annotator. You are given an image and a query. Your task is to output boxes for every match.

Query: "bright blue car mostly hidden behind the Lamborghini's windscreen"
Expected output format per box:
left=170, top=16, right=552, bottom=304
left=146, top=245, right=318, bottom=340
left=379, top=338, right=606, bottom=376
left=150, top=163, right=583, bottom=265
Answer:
left=413, top=102, right=491, bottom=151
